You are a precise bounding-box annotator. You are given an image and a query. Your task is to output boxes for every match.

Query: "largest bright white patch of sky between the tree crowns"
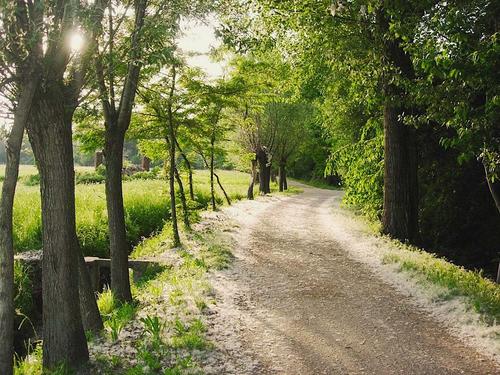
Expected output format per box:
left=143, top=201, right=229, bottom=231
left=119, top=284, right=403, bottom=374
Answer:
left=179, top=17, right=224, bottom=78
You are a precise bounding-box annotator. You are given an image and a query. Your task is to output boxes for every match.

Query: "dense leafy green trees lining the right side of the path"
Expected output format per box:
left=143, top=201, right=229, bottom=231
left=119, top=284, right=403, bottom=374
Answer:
left=220, top=0, right=500, bottom=274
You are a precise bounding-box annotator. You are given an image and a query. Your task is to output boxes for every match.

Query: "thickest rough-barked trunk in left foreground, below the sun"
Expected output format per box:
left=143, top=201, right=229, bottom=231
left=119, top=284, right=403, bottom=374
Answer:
left=27, top=94, right=88, bottom=368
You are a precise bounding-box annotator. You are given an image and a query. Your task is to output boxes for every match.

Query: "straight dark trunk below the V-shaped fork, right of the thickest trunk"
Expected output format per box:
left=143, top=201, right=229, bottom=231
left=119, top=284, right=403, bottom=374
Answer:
left=105, top=132, right=132, bottom=302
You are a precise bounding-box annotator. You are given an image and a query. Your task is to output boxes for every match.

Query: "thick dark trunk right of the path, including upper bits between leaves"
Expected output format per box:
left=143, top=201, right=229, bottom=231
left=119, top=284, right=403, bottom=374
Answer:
left=377, top=7, right=418, bottom=241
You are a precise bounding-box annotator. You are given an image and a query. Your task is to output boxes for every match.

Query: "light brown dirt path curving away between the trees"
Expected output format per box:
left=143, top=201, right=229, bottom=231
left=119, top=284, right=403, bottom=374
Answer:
left=205, top=186, right=500, bottom=375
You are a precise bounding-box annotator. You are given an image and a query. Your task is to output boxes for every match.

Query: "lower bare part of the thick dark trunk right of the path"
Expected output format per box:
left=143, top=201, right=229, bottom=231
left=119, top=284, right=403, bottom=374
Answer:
left=382, top=99, right=418, bottom=241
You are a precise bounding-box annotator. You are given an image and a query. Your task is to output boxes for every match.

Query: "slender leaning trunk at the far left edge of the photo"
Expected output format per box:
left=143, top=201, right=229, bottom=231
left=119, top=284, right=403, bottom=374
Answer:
left=0, top=79, right=38, bottom=375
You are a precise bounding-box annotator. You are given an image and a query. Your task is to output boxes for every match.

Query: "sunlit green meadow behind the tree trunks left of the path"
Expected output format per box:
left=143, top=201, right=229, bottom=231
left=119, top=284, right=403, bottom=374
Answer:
left=0, top=165, right=249, bottom=257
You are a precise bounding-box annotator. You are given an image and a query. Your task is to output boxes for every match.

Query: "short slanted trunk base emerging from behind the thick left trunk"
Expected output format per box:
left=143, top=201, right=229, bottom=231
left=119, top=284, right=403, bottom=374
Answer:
left=75, top=253, right=104, bottom=333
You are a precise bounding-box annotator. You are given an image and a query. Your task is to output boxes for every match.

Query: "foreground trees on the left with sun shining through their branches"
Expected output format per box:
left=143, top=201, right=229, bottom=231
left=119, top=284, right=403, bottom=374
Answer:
left=0, top=0, right=211, bottom=374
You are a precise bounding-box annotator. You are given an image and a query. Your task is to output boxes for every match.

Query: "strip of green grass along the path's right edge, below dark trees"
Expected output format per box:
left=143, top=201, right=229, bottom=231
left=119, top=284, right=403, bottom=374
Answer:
left=383, top=246, right=500, bottom=323
